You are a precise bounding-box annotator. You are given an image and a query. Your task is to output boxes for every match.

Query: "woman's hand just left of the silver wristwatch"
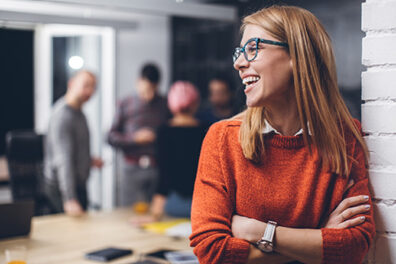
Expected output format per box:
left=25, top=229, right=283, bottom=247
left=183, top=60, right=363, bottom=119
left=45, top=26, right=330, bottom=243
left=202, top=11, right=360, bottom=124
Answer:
left=231, top=215, right=267, bottom=243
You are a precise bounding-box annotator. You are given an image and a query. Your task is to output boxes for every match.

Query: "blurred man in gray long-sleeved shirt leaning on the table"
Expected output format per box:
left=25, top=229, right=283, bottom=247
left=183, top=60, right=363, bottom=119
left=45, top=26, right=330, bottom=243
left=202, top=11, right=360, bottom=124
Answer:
left=44, top=71, right=103, bottom=216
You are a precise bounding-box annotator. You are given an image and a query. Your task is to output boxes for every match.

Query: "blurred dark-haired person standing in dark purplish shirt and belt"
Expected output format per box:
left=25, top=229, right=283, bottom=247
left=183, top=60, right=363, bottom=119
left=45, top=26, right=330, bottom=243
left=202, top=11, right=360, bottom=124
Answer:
left=108, top=64, right=169, bottom=206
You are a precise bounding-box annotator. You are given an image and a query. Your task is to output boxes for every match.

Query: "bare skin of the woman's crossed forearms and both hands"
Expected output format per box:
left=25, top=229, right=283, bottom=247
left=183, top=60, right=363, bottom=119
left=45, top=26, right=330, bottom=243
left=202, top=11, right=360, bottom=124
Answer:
left=232, top=195, right=370, bottom=263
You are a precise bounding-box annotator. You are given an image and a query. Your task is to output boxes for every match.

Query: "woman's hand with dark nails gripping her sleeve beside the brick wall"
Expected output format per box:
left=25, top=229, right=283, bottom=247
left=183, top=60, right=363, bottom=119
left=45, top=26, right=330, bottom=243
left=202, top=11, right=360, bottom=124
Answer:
left=322, top=180, right=370, bottom=229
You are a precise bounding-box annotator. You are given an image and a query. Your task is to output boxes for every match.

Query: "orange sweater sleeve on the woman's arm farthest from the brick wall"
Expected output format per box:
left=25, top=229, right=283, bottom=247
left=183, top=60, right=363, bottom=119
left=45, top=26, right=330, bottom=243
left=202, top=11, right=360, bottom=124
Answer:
left=190, top=123, right=249, bottom=264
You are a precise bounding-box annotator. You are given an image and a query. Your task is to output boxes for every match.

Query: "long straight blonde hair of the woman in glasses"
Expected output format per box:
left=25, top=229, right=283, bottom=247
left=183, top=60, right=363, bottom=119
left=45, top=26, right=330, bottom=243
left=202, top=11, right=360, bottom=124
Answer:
left=239, top=5, right=367, bottom=175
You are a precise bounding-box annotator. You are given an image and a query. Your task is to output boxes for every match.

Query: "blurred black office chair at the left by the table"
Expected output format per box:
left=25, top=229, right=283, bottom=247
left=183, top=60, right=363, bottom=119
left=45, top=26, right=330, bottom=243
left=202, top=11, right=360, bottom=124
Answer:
left=6, top=130, right=52, bottom=215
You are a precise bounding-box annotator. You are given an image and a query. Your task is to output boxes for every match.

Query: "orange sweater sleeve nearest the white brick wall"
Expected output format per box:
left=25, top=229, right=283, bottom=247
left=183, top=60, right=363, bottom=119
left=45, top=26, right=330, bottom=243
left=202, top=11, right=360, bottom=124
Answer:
left=322, top=139, right=375, bottom=263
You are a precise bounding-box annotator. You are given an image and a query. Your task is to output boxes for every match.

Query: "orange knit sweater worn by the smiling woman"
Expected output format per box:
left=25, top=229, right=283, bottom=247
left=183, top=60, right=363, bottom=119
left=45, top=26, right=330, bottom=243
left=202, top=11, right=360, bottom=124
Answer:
left=190, top=121, right=375, bottom=264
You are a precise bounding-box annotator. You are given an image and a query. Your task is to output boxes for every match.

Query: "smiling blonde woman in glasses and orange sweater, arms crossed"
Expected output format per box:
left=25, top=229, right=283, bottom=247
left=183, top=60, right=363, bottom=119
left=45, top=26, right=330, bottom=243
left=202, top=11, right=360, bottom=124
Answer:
left=190, top=6, right=375, bottom=264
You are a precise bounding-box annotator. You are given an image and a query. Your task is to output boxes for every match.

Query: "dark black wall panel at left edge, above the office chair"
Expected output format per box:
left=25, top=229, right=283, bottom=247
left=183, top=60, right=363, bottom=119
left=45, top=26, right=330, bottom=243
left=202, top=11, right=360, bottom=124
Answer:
left=0, top=29, right=34, bottom=155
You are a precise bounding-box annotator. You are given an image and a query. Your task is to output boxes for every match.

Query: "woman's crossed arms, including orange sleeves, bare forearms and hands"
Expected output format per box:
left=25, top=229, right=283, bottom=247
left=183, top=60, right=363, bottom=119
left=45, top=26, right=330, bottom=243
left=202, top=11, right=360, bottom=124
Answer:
left=190, top=124, right=375, bottom=264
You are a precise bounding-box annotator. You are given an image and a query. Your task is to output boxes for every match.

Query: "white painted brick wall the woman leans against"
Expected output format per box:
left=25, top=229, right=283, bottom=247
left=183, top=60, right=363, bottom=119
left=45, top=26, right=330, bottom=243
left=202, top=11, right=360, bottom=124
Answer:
left=362, top=0, right=396, bottom=264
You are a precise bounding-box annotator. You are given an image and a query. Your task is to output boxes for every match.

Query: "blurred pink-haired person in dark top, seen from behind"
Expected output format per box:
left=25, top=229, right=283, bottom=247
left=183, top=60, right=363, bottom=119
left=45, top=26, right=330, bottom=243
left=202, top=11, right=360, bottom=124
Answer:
left=133, top=81, right=208, bottom=225
